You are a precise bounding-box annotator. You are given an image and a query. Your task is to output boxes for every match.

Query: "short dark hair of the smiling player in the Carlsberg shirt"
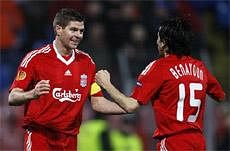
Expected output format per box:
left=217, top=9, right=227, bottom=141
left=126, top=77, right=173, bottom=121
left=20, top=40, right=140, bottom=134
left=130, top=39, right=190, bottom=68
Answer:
left=53, top=8, right=85, bottom=29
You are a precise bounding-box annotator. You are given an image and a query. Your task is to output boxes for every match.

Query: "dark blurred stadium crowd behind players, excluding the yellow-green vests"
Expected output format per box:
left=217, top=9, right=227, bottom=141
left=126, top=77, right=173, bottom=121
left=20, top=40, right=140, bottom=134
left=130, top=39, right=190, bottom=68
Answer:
left=0, top=0, right=230, bottom=150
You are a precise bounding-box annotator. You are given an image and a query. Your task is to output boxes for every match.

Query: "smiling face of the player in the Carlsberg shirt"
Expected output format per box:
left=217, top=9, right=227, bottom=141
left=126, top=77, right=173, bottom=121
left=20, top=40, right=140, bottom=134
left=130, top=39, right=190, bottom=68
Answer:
left=60, top=21, right=85, bottom=50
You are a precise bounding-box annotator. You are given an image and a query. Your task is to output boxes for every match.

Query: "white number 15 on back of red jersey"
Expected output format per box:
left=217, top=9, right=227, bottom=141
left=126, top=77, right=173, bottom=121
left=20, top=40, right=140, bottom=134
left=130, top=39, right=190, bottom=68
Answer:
left=176, top=83, right=203, bottom=122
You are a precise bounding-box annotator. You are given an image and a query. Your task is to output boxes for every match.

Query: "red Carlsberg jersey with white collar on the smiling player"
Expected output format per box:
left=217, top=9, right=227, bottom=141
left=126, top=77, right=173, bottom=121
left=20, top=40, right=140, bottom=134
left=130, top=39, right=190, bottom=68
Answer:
left=10, top=41, right=102, bottom=135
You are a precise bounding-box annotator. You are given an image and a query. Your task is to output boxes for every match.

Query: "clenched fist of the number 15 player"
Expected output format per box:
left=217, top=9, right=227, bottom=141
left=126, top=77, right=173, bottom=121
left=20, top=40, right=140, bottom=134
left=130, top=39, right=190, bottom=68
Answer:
left=95, top=70, right=111, bottom=89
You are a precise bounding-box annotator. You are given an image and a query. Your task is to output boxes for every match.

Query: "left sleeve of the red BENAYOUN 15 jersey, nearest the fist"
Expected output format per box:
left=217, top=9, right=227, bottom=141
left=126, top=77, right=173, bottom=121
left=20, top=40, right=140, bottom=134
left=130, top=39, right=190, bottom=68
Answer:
left=131, top=62, right=163, bottom=104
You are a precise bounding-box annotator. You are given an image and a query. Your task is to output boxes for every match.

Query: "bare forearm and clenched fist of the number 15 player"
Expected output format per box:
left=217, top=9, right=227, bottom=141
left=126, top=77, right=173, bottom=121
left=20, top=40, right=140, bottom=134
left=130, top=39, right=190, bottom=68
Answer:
left=96, top=70, right=140, bottom=113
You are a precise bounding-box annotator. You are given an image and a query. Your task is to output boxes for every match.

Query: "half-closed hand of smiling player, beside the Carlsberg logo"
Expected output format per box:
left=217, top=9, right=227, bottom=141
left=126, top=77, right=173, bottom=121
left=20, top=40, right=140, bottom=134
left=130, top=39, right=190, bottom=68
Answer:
left=33, top=80, right=50, bottom=98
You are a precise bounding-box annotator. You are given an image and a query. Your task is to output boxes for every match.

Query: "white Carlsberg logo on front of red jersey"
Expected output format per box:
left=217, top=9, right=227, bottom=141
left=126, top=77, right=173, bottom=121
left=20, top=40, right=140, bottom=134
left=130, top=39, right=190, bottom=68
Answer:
left=52, top=88, right=81, bottom=102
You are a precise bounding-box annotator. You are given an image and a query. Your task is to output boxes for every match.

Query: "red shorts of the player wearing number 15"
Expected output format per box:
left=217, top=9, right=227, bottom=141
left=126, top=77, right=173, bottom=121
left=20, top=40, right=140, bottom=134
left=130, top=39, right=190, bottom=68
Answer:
left=157, top=131, right=206, bottom=151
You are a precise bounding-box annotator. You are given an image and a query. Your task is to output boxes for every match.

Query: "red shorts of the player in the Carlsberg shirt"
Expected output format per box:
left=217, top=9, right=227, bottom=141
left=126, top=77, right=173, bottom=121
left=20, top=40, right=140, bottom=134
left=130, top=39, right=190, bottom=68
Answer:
left=24, top=129, right=77, bottom=151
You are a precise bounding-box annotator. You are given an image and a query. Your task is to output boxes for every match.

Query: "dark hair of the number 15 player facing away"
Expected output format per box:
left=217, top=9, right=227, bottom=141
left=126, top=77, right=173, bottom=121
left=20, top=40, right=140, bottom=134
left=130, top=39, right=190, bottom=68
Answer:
left=159, top=17, right=193, bottom=56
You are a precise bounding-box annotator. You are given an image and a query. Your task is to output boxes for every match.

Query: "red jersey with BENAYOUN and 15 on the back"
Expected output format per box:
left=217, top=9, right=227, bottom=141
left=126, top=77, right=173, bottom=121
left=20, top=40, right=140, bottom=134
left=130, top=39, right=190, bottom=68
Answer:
left=132, top=55, right=225, bottom=137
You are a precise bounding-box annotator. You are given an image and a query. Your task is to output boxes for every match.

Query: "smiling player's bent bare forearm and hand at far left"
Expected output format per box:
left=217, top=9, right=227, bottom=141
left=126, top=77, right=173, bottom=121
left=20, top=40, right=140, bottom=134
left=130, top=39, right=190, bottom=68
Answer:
left=8, top=80, right=50, bottom=106
